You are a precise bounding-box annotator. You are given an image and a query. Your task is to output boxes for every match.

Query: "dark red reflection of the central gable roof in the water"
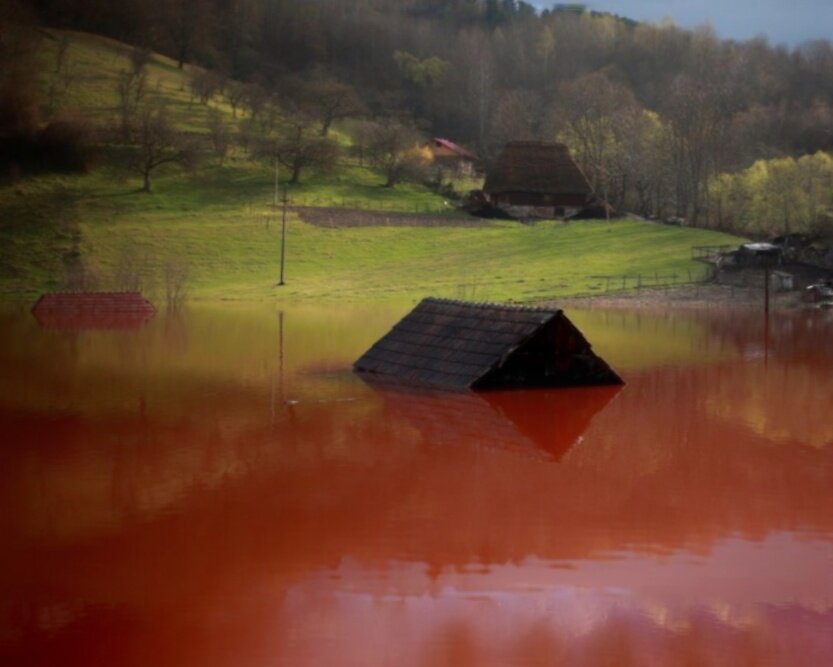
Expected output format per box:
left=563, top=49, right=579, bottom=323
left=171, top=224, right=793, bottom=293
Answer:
left=371, top=383, right=620, bottom=461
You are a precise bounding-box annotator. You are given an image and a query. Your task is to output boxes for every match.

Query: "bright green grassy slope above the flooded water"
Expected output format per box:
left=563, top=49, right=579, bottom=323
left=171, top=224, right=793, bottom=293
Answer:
left=0, top=30, right=731, bottom=300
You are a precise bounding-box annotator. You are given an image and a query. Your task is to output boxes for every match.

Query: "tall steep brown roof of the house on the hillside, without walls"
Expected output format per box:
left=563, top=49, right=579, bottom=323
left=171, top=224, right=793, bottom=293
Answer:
left=483, top=141, right=591, bottom=195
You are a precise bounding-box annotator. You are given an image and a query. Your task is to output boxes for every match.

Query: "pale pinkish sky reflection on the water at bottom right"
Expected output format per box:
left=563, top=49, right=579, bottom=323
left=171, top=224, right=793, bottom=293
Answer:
left=284, top=534, right=833, bottom=665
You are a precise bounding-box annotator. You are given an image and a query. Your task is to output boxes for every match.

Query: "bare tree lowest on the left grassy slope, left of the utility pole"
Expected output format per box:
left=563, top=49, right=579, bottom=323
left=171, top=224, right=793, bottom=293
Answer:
left=132, top=104, right=195, bottom=192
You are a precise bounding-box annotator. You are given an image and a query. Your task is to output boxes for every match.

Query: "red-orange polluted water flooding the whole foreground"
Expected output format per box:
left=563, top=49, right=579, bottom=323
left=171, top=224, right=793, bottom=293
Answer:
left=0, top=306, right=833, bottom=667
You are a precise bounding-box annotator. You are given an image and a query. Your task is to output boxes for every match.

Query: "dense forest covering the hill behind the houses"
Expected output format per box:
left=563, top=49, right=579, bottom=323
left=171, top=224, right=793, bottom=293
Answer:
left=7, top=0, right=833, bottom=232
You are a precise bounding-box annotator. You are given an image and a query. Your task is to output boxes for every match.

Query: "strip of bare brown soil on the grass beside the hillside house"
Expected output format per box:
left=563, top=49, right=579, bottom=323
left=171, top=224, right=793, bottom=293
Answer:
left=289, top=206, right=488, bottom=227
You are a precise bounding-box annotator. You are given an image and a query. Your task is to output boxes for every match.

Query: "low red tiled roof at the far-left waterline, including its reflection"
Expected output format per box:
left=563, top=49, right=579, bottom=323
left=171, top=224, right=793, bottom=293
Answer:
left=32, top=292, right=156, bottom=329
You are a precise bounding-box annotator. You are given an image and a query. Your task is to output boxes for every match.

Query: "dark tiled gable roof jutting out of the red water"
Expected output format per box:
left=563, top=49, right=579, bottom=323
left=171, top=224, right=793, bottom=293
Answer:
left=353, top=298, right=622, bottom=390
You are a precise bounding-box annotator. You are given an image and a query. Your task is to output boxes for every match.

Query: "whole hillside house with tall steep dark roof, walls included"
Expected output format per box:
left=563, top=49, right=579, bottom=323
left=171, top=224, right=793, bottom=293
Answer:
left=483, top=141, right=595, bottom=218
